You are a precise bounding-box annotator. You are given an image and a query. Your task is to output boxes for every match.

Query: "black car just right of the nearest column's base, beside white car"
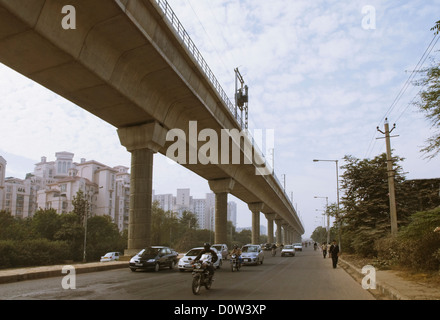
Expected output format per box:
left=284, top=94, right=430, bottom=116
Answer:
left=129, top=246, right=178, bottom=272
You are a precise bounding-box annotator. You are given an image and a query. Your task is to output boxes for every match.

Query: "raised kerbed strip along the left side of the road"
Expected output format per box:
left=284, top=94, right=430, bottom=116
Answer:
left=0, top=261, right=128, bottom=284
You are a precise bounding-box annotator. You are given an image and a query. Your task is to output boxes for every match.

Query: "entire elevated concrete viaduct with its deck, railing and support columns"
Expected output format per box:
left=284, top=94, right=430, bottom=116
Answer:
left=0, top=0, right=304, bottom=254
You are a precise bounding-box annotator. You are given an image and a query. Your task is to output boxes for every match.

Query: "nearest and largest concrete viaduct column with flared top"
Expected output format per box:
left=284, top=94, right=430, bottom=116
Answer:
left=118, top=122, right=166, bottom=256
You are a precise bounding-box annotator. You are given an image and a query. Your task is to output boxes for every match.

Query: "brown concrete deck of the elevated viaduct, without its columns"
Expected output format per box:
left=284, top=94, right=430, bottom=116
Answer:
left=0, top=0, right=303, bottom=233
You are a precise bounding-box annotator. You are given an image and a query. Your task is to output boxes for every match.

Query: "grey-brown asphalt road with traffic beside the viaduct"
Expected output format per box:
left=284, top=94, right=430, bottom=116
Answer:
left=0, top=248, right=374, bottom=301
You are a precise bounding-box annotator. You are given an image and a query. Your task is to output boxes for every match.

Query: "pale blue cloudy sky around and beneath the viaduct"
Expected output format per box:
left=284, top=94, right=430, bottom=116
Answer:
left=0, top=0, right=440, bottom=238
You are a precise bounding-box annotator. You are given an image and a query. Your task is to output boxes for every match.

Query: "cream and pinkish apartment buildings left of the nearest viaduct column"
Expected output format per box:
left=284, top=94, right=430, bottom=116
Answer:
left=0, top=151, right=130, bottom=231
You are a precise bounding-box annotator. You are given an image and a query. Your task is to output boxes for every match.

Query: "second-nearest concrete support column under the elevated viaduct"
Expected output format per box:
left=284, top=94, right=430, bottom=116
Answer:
left=208, top=178, right=235, bottom=244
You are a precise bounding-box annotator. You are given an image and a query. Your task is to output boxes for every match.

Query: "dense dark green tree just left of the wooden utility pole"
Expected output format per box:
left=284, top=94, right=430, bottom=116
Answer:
left=341, top=153, right=404, bottom=256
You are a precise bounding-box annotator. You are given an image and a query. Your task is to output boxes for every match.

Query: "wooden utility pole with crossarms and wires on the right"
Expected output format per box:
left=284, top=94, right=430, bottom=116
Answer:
left=377, top=118, right=398, bottom=236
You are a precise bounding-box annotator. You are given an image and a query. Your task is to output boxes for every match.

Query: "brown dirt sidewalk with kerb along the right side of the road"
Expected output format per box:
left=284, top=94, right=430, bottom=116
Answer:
left=339, top=258, right=440, bottom=300
